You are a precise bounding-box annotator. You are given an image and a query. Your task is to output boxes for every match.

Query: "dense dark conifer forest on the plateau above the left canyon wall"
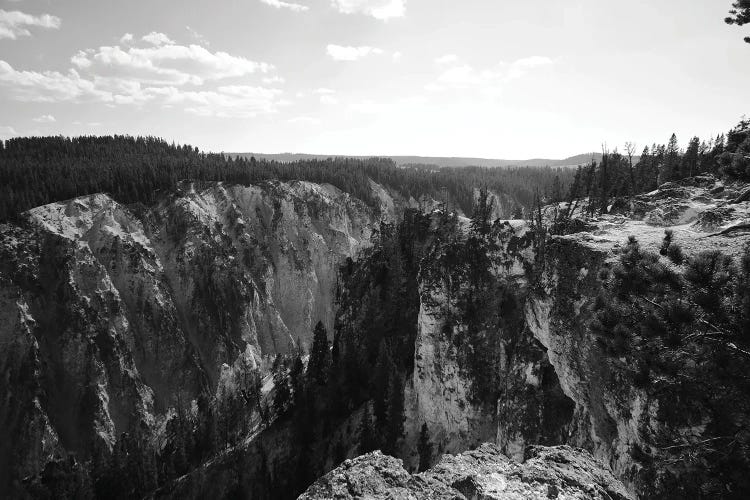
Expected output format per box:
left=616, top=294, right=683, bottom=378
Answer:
left=0, top=136, right=574, bottom=220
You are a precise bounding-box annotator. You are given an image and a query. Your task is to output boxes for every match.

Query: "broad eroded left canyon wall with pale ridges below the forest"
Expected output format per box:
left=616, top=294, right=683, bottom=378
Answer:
left=0, top=182, right=379, bottom=491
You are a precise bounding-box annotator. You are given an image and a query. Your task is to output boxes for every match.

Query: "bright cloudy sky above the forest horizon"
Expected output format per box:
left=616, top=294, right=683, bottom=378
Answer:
left=0, top=0, right=750, bottom=159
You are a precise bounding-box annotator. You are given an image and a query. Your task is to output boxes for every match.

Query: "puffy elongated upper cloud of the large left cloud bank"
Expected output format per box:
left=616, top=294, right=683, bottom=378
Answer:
left=71, top=38, right=273, bottom=85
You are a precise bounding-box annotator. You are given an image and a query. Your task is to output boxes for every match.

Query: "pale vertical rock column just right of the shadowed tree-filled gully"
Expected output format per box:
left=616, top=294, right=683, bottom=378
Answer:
left=405, top=221, right=574, bottom=466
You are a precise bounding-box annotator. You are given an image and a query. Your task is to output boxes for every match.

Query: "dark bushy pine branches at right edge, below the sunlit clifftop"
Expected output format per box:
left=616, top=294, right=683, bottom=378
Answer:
left=590, top=236, right=750, bottom=498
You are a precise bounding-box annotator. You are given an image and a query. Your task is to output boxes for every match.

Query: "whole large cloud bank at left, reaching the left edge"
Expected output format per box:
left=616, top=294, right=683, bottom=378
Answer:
left=0, top=33, right=288, bottom=119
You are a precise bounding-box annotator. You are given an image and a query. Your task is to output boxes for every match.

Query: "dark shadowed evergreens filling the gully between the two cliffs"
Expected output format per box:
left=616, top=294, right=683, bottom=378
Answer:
left=250, top=210, right=431, bottom=498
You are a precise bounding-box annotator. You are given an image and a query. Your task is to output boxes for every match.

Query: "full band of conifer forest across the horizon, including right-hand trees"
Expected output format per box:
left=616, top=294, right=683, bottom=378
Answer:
left=0, top=120, right=750, bottom=220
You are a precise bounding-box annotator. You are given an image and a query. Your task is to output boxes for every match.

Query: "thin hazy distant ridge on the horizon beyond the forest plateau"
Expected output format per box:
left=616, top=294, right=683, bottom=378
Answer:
left=228, top=153, right=612, bottom=167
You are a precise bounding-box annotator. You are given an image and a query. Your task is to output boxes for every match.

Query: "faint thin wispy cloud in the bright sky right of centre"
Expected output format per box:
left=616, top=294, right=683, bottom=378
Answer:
left=426, top=56, right=554, bottom=92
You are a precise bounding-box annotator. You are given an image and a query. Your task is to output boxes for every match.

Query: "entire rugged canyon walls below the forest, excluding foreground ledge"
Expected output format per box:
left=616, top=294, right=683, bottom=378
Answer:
left=0, top=177, right=750, bottom=498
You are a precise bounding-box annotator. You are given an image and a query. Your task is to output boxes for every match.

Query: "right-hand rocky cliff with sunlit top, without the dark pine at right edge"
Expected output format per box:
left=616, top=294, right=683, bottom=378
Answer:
left=405, top=178, right=750, bottom=497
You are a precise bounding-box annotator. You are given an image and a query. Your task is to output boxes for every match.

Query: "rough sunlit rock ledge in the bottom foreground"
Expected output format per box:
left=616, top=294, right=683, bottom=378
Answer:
left=299, top=444, right=634, bottom=500
